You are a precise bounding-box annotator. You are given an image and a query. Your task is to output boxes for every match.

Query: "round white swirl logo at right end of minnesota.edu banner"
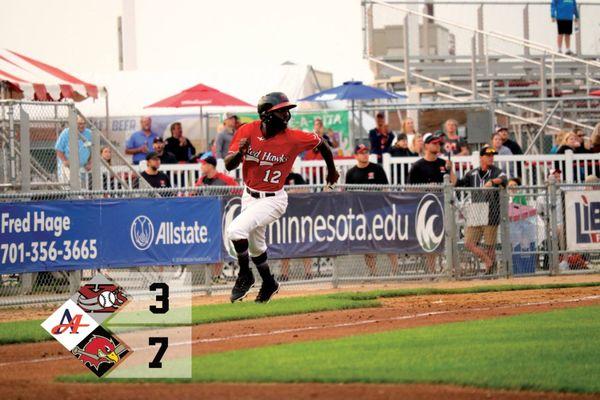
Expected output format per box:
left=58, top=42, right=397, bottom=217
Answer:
left=415, top=194, right=444, bottom=253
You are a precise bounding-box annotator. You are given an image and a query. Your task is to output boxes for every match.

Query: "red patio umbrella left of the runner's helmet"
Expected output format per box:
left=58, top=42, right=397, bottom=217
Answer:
left=144, top=83, right=252, bottom=145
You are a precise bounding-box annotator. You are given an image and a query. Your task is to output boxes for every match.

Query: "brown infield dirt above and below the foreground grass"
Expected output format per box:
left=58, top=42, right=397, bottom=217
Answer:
left=0, top=282, right=600, bottom=400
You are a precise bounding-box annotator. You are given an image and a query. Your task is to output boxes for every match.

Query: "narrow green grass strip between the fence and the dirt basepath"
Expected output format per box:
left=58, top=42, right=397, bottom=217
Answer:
left=0, top=282, right=600, bottom=345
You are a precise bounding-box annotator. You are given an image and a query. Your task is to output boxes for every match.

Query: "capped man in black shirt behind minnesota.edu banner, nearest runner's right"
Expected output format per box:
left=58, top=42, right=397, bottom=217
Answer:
left=346, top=144, right=398, bottom=276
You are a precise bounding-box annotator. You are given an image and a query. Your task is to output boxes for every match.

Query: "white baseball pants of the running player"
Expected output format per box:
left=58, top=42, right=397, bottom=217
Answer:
left=227, top=188, right=288, bottom=257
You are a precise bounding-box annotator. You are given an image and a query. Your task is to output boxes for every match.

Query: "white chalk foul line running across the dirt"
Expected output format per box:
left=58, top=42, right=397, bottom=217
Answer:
left=0, top=295, right=600, bottom=367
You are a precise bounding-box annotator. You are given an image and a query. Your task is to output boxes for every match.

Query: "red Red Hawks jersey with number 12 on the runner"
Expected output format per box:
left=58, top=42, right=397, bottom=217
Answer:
left=229, top=121, right=321, bottom=192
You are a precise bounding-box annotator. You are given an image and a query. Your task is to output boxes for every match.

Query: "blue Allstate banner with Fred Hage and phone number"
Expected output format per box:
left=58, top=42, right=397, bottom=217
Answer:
left=0, top=197, right=222, bottom=273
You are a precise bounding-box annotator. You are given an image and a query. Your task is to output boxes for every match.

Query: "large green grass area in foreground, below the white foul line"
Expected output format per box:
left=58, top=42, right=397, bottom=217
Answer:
left=61, top=306, right=600, bottom=392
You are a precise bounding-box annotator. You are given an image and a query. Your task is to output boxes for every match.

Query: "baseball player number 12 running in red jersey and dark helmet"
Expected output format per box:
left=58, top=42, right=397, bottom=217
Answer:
left=225, top=92, right=339, bottom=303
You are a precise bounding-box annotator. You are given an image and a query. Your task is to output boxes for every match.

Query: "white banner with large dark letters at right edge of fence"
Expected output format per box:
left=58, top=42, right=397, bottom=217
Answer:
left=565, top=190, right=600, bottom=250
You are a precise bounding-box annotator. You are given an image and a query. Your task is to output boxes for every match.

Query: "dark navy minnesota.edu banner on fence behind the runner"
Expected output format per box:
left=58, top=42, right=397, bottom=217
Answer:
left=223, top=192, right=444, bottom=258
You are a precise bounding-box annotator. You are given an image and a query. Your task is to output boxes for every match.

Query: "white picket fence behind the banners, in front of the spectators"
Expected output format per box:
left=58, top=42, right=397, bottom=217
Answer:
left=102, top=152, right=600, bottom=190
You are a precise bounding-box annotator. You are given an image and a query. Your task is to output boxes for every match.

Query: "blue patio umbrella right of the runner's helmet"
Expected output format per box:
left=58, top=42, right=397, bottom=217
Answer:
left=298, top=81, right=406, bottom=145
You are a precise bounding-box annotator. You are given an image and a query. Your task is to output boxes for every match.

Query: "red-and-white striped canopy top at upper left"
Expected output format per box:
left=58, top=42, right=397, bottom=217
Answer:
left=0, top=49, right=105, bottom=101
